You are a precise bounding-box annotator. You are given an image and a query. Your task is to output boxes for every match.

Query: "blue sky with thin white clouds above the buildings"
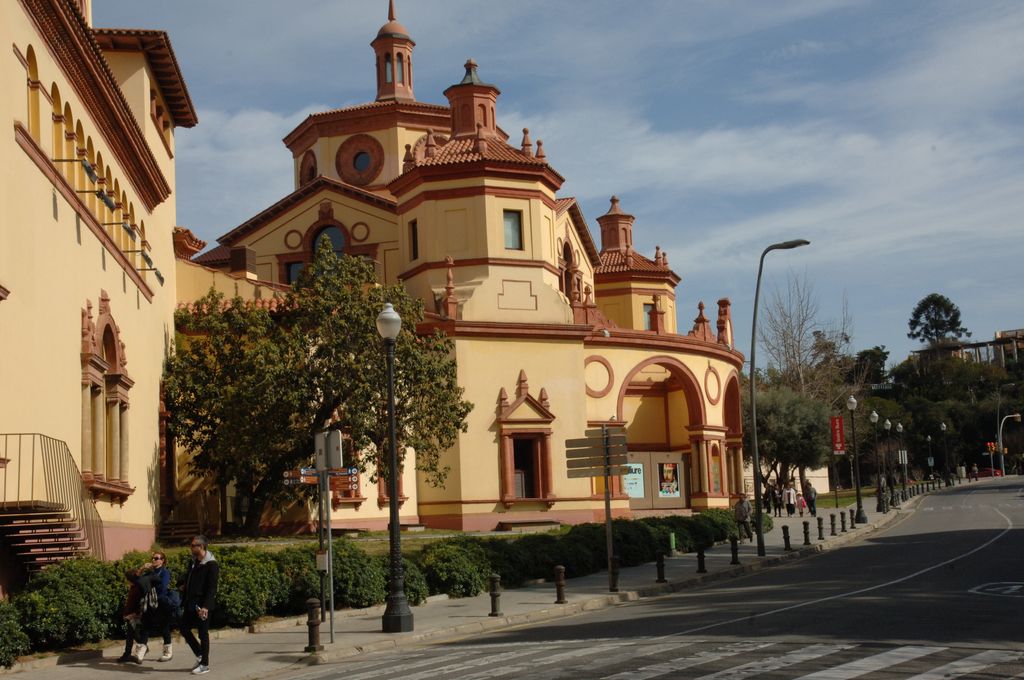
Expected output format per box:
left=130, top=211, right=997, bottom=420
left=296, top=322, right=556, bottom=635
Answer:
left=93, top=0, right=1024, bottom=364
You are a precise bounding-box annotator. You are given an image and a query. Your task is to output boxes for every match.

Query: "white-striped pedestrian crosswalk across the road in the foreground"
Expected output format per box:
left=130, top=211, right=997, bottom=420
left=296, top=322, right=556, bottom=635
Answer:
left=309, top=636, right=1024, bottom=680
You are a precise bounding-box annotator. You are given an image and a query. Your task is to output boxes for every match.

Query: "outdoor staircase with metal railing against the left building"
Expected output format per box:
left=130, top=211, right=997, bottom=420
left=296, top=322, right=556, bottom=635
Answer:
left=0, top=433, right=103, bottom=573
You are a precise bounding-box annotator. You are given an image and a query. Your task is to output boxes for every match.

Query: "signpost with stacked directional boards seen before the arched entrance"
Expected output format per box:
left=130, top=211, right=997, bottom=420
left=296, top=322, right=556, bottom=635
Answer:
left=565, top=425, right=630, bottom=592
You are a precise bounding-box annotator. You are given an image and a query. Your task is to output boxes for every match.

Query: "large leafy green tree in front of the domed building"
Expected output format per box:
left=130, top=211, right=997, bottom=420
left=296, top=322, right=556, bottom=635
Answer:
left=166, top=244, right=472, bottom=535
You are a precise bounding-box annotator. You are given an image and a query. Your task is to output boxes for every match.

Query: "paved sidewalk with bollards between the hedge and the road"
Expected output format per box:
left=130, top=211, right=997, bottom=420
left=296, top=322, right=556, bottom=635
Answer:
left=0, top=481, right=962, bottom=680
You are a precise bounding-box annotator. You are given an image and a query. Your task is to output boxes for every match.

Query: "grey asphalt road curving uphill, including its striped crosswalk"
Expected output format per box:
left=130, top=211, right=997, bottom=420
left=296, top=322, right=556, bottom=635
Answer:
left=282, top=477, right=1024, bottom=680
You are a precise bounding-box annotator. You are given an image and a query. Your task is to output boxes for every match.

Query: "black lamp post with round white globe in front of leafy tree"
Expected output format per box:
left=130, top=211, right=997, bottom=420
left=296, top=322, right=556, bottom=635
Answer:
left=377, top=302, right=413, bottom=633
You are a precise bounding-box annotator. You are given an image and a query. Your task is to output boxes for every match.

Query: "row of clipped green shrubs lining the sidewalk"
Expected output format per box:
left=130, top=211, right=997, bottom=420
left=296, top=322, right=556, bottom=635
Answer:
left=0, top=510, right=770, bottom=666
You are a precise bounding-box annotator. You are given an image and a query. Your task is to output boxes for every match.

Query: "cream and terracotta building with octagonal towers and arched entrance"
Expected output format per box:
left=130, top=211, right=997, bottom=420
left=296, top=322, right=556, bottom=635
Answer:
left=195, top=6, right=743, bottom=529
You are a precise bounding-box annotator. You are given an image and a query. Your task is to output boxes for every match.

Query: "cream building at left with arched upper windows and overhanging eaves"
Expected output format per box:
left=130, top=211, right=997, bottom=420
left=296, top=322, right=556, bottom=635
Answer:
left=0, top=0, right=207, bottom=590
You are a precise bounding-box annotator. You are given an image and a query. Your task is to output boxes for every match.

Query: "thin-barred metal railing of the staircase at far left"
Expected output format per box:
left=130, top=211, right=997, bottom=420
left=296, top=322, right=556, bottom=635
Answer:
left=0, top=432, right=105, bottom=558
